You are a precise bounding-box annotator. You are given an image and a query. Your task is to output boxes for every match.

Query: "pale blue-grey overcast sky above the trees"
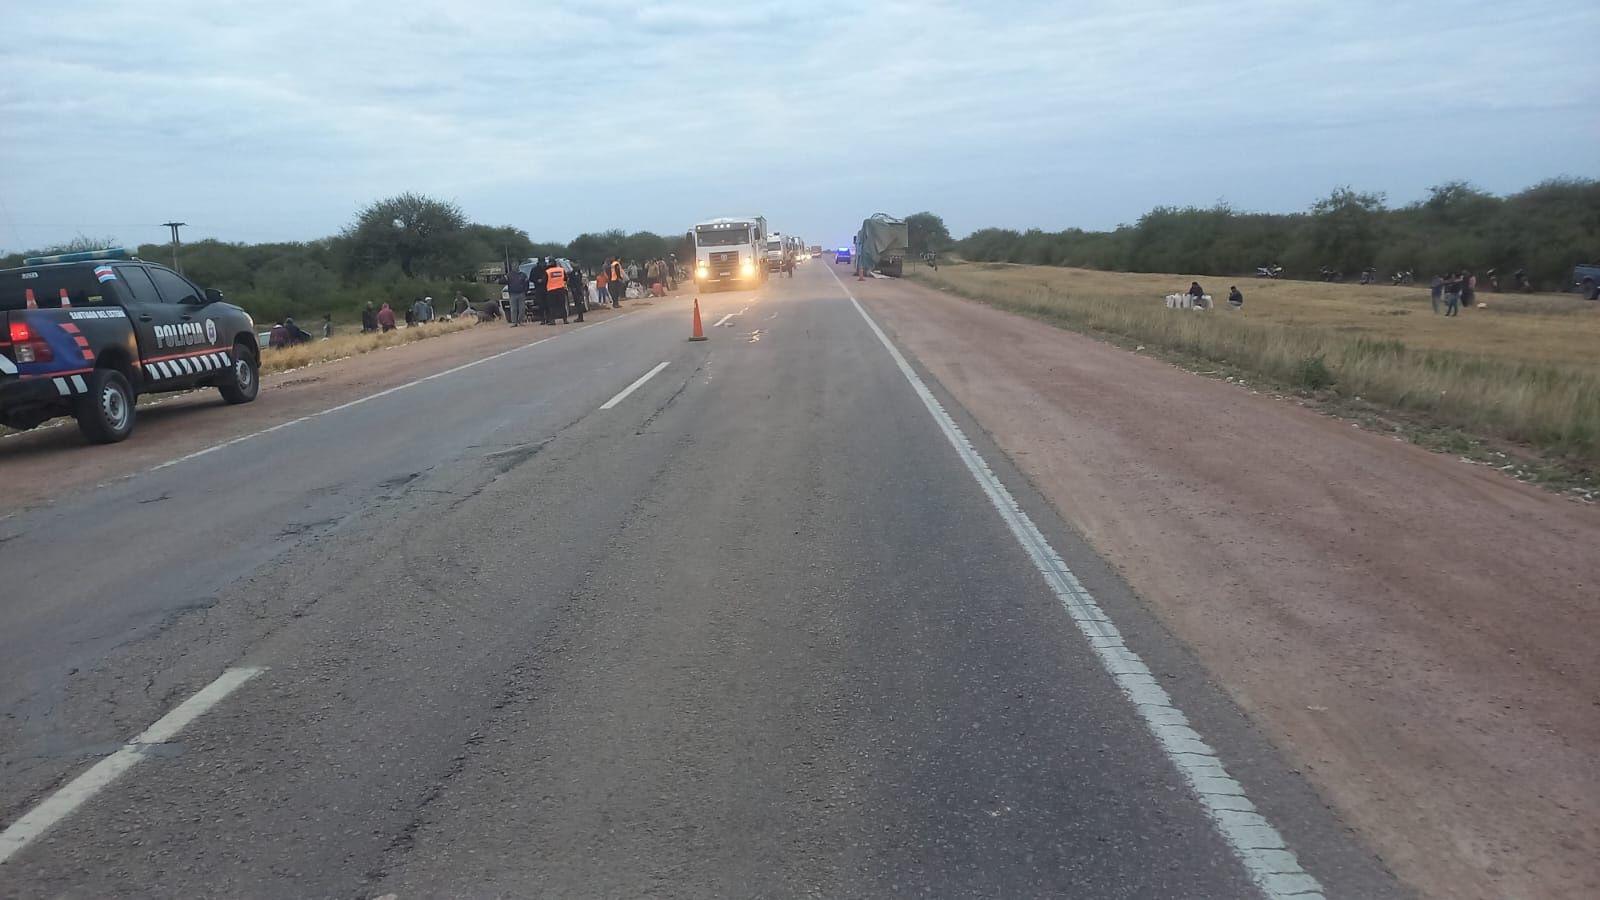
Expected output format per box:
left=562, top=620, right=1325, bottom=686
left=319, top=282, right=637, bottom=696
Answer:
left=0, top=0, right=1600, bottom=250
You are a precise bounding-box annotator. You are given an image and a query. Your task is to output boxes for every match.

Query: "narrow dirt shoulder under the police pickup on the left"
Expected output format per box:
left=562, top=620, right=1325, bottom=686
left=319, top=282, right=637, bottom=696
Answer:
left=0, top=306, right=649, bottom=517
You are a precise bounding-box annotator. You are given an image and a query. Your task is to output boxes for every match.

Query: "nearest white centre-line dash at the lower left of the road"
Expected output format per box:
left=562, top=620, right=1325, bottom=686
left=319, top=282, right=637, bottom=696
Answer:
left=0, top=666, right=266, bottom=865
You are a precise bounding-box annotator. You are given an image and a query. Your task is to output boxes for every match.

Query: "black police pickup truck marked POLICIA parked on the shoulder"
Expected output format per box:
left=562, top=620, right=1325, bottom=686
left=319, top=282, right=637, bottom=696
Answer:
left=0, top=250, right=261, bottom=444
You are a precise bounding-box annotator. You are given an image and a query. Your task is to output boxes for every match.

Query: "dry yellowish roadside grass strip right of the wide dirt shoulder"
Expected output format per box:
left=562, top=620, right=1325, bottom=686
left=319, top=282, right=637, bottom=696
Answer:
left=909, top=263, right=1600, bottom=484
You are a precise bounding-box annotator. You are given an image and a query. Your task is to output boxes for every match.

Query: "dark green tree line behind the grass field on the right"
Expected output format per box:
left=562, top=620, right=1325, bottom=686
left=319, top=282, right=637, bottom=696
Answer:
left=934, top=178, right=1600, bottom=290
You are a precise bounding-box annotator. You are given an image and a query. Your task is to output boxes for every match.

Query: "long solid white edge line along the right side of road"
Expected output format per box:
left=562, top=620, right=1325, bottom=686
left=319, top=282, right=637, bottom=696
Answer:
left=829, top=271, right=1323, bottom=900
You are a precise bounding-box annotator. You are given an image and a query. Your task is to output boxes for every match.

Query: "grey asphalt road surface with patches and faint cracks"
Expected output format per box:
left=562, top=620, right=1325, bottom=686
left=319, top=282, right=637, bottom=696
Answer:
left=0, top=261, right=1394, bottom=897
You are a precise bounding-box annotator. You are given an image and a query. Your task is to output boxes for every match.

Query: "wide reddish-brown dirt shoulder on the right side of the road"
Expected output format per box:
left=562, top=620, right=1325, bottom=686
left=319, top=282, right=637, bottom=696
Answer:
left=854, top=280, right=1600, bottom=897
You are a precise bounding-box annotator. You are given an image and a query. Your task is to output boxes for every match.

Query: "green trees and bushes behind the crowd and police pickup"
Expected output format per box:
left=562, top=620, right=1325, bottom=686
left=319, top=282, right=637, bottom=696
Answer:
left=0, top=194, right=693, bottom=322
